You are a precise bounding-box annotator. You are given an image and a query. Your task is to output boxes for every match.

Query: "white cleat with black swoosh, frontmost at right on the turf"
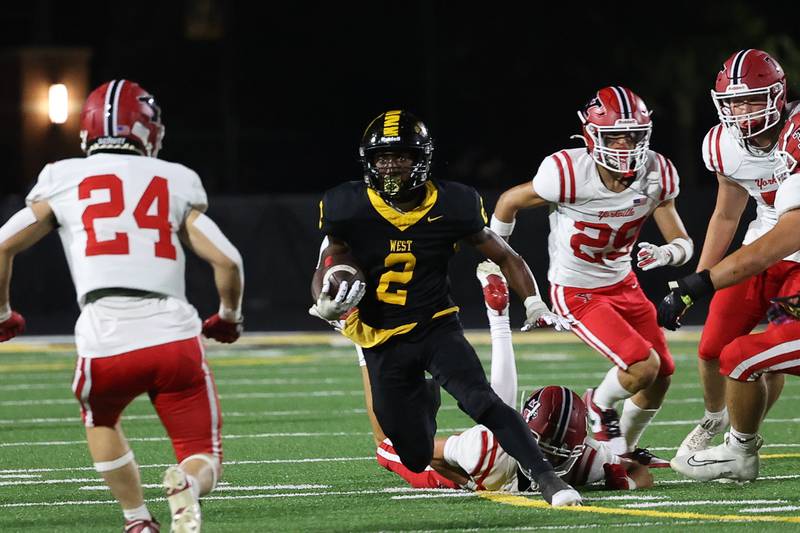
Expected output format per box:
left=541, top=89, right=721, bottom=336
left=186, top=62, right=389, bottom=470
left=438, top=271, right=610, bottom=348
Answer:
left=670, top=433, right=764, bottom=481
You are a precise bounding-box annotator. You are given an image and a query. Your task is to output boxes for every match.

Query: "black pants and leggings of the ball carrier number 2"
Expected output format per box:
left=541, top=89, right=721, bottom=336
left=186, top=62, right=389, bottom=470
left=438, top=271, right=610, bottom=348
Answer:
left=364, top=315, right=552, bottom=474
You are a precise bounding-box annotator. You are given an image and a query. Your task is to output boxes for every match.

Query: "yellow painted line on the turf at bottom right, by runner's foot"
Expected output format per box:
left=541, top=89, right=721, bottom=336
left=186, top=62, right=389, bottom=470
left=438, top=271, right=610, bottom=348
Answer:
left=478, top=492, right=800, bottom=524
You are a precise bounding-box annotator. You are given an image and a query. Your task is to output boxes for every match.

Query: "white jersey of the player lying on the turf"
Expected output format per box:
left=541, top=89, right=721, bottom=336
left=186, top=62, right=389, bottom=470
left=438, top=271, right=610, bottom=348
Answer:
left=444, top=425, right=621, bottom=492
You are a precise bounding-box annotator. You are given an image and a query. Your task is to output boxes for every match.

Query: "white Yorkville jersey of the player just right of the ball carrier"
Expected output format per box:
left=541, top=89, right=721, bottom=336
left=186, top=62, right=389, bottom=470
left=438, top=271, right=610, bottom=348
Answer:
left=532, top=148, right=680, bottom=289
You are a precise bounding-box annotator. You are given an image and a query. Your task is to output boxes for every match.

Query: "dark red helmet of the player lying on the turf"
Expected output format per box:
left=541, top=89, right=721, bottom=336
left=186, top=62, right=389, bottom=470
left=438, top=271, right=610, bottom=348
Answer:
left=522, top=385, right=586, bottom=476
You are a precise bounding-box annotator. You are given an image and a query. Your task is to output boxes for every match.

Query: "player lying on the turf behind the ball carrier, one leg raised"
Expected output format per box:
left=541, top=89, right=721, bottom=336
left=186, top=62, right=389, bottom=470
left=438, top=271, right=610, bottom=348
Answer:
left=359, top=261, right=653, bottom=492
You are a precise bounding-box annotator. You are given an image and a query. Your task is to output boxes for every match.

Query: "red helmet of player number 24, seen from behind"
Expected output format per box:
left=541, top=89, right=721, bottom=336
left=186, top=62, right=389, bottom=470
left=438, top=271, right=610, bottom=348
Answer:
left=81, top=80, right=164, bottom=157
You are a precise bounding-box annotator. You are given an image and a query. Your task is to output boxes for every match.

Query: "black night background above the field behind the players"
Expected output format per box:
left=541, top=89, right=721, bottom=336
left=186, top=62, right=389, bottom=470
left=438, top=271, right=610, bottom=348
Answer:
left=0, top=0, right=800, bottom=332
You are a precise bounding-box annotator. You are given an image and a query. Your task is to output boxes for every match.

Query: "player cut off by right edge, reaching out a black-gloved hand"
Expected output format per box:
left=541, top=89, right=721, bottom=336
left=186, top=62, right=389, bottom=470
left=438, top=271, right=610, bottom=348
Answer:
left=658, top=109, right=800, bottom=481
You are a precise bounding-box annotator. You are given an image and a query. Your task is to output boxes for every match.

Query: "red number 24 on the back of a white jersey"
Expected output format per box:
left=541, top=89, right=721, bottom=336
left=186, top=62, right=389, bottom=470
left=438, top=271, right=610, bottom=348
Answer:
left=78, top=174, right=177, bottom=259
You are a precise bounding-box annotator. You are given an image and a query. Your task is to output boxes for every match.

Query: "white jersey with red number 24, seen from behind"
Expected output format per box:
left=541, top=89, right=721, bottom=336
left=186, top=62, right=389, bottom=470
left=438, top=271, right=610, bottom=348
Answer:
left=26, top=154, right=208, bottom=357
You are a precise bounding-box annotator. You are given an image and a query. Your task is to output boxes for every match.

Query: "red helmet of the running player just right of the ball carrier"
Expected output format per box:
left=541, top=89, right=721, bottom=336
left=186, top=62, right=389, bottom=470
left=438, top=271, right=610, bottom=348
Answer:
left=578, top=85, right=653, bottom=175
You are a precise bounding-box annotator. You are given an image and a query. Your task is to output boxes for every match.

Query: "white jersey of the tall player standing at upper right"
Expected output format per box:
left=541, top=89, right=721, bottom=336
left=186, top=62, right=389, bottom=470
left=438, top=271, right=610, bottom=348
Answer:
left=703, top=103, right=800, bottom=262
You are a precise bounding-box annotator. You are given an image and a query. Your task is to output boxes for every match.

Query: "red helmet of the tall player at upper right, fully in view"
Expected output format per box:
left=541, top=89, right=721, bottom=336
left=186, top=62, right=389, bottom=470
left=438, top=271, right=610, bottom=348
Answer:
left=711, top=48, right=786, bottom=147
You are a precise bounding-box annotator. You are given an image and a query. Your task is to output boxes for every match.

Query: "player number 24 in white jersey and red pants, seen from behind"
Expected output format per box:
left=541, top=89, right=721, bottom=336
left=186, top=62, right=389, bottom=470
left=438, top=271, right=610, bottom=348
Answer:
left=0, top=80, right=244, bottom=533
